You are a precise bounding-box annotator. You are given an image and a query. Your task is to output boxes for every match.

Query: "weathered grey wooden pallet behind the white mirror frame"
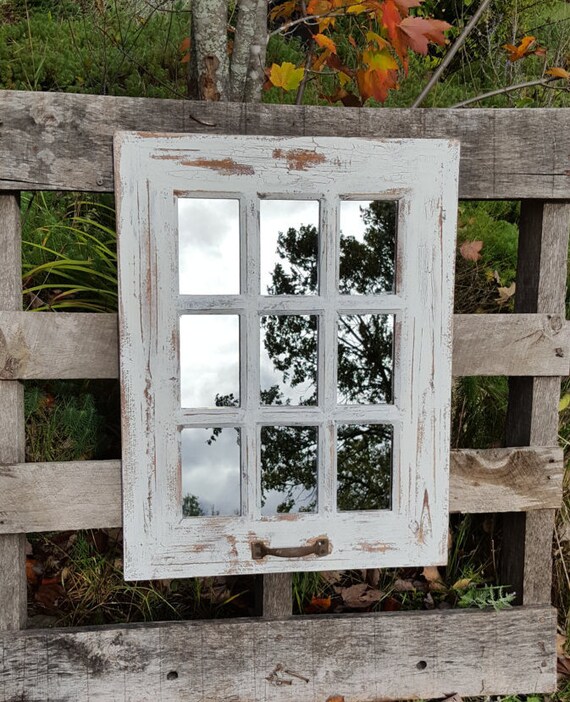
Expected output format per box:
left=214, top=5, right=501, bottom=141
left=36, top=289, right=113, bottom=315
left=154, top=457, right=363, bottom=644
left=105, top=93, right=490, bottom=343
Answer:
left=0, top=92, right=570, bottom=702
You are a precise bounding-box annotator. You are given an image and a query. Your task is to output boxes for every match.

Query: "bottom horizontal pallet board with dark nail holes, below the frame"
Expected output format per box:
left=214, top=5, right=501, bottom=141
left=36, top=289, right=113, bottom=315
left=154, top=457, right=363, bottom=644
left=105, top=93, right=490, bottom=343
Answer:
left=0, top=606, right=556, bottom=702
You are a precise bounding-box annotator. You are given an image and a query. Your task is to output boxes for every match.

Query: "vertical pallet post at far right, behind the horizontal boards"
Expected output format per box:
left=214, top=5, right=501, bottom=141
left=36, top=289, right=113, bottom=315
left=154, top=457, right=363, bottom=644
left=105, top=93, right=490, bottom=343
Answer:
left=500, top=201, right=570, bottom=604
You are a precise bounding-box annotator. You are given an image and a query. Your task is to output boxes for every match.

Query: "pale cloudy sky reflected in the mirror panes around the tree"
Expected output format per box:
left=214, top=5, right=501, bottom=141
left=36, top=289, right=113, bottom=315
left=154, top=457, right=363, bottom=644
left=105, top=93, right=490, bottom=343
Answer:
left=178, top=198, right=368, bottom=515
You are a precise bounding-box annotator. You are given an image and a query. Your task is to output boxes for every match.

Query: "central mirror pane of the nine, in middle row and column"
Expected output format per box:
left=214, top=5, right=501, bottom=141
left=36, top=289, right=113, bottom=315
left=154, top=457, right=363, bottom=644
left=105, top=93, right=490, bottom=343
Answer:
left=260, top=314, right=318, bottom=405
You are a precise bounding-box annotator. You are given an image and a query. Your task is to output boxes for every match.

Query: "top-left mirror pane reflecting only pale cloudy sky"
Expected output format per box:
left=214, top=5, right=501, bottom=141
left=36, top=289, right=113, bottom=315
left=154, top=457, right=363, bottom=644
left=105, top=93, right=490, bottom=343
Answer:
left=178, top=198, right=239, bottom=295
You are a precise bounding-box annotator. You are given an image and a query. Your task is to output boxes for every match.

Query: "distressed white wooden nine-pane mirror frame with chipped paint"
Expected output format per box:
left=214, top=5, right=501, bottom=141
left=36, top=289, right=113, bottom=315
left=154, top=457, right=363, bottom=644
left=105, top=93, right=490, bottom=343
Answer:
left=115, top=132, right=459, bottom=579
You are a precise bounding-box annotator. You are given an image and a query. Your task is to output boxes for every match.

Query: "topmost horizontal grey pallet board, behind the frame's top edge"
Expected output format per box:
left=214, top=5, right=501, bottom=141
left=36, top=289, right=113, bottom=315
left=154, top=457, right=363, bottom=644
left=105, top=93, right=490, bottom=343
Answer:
left=0, top=91, right=570, bottom=199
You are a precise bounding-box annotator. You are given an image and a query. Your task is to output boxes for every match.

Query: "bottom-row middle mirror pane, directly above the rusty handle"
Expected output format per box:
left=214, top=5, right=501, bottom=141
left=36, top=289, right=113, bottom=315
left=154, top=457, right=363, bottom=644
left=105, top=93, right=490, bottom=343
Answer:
left=261, top=426, right=318, bottom=516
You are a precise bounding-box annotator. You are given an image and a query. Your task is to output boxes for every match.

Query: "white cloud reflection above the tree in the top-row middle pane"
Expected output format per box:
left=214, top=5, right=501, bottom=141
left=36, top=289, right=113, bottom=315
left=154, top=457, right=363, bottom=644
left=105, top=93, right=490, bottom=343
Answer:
left=259, top=200, right=319, bottom=295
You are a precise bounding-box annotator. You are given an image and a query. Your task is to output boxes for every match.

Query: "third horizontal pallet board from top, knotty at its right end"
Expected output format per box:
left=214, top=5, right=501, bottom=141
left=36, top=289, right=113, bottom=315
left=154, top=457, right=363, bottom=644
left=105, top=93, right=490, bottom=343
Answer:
left=0, top=447, right=563, bottom=534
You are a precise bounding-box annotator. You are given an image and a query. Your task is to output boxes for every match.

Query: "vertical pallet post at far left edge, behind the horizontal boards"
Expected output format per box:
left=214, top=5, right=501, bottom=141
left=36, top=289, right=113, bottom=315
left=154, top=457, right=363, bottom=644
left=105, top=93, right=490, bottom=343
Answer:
left=0, top=195, right=27, bottom=631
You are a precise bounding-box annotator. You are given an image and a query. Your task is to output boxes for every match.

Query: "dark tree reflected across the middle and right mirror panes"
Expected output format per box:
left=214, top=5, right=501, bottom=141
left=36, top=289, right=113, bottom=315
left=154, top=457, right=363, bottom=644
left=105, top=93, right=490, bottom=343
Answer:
left=261, top=201, right=396, bottom=511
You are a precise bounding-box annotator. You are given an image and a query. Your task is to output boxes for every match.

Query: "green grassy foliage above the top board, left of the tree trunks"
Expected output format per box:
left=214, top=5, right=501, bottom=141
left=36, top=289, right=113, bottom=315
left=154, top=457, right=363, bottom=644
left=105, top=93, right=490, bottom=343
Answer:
left=0, top=2, right=188, bottom=98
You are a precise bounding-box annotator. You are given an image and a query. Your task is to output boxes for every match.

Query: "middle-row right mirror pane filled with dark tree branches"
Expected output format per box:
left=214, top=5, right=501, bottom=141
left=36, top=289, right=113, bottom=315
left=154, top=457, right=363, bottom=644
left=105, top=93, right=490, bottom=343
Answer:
left=337, top=314, right=394, bottom=405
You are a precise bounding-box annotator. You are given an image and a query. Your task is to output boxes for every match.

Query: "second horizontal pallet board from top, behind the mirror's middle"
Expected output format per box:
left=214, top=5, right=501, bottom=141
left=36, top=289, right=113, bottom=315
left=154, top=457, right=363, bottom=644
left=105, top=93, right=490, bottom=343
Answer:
left=0, top=312, right=570, bottom=380
